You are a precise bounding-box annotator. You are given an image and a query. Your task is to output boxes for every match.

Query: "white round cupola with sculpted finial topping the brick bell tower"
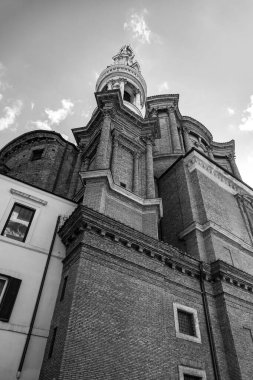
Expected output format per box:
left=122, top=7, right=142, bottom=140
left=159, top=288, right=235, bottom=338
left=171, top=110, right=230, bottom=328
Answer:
left=96, top=45, right=147, bottom=117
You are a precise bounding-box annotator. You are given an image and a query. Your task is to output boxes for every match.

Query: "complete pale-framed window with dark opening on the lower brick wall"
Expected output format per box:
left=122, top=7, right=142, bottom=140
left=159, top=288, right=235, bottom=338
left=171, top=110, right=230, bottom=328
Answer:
left=173, top=303, right=201, bottom=344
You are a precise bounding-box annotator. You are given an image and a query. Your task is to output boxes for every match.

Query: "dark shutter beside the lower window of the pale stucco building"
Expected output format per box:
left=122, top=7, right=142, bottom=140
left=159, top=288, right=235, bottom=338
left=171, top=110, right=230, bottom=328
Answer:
left=0, top=277, right=21, bottom=322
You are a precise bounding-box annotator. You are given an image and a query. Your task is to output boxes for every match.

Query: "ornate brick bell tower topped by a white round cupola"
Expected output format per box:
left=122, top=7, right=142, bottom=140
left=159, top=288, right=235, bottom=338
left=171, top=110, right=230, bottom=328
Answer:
left=73, top=45, right=162, bottom=238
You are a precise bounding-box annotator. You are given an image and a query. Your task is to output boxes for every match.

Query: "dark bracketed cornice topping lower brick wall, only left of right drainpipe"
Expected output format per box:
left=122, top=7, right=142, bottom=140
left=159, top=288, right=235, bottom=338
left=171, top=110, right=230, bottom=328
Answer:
left=59, top=205, right=199, bottom=277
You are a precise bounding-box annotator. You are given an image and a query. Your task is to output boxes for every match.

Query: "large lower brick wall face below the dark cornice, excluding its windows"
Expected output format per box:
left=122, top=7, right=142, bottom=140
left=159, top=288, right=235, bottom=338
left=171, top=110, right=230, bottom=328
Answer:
left=41, top=227, right=229, bottom=380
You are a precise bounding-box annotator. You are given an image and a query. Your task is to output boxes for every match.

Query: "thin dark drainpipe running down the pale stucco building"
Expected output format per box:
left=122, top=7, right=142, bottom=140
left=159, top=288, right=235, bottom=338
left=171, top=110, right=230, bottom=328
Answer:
left=16, top=216, right=60, bottom=379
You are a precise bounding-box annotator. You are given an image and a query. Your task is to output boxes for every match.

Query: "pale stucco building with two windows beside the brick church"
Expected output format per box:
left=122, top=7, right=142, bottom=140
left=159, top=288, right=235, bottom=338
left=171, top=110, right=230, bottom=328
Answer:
left=0, top=174, right=76, bottom=380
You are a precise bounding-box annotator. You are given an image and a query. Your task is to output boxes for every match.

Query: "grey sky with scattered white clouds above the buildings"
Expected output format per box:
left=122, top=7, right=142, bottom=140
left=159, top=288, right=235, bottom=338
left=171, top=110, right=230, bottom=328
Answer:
left=0, top=0, right=253, bottom=187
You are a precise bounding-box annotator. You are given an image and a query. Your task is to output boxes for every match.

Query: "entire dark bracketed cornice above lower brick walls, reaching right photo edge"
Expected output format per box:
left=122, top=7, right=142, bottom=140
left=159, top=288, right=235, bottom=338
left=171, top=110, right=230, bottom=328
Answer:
left=59, top=205, right=253, bottom=293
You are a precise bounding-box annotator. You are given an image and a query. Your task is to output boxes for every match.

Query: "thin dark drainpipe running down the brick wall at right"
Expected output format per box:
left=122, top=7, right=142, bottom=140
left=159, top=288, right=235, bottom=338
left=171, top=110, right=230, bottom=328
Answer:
left=199, top=261, right=221, bottom=380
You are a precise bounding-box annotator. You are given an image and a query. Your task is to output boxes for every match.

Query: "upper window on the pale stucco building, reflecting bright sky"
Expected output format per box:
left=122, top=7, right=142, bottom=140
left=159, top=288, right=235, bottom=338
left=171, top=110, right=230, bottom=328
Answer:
left=2, top=203, right=35, bottom=241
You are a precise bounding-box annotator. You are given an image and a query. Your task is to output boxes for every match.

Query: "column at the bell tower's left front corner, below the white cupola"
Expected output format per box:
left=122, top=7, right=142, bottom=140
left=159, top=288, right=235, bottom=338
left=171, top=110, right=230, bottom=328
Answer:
left=95, top=110, right=111, bottom=169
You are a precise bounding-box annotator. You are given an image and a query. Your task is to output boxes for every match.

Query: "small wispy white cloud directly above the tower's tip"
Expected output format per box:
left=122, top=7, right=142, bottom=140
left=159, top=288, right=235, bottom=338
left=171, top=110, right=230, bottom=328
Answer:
left=123, top=9, right=152, bottom=44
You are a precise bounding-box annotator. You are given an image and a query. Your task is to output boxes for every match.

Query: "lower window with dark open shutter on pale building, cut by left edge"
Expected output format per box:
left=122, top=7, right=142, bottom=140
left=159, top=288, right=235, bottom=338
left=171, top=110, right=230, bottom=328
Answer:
left=0, top=275, right=21, bottom=322
